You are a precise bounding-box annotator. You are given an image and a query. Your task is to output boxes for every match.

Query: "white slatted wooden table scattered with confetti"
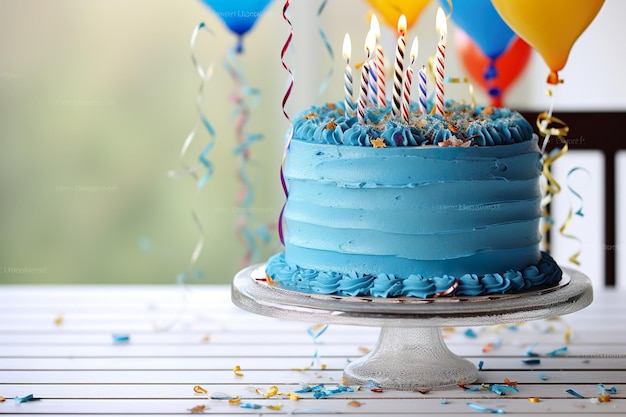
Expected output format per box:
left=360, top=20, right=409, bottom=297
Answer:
left=0, top=285, right=626, bottom=416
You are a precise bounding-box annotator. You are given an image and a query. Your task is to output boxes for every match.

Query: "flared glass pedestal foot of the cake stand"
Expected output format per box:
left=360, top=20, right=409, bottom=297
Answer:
left=344, top=327, right=478, bottom=391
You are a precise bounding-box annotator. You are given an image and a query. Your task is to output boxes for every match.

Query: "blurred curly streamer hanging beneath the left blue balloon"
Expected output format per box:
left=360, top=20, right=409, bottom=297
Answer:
left=225, top=50, right=263, bottom=266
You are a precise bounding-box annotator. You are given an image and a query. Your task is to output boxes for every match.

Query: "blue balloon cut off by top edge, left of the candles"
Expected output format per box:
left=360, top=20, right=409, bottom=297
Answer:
left=201, top=0, right=271, bottom=53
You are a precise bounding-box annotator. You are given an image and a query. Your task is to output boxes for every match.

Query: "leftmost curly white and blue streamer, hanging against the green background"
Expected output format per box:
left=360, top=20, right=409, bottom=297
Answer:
left=168, top=22, right=215, bottom=276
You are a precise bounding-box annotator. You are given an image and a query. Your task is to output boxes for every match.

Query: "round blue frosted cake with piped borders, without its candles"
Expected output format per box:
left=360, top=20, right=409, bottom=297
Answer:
left=266, top=102, right=562, bottom=298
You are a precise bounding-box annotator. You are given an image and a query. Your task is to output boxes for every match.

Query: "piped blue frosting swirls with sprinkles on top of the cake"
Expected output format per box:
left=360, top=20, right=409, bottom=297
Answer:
left=293, top=101, right=533, bottom=147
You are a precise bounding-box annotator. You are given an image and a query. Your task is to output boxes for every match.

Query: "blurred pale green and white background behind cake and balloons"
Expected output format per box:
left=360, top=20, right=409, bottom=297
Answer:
left=0, top=0, right=626, bottom=284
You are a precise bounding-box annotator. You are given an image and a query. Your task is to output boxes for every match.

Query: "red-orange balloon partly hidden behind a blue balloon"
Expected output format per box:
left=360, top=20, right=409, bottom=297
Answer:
left=454, top=28, right=532, bottom=107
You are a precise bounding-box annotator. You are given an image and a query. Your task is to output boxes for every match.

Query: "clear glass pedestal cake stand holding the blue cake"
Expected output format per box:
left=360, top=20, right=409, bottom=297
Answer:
left=231, top=264, right=593, bottom=391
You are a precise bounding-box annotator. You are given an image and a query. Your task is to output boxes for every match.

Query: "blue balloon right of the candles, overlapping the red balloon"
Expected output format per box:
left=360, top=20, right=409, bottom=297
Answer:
left=441, top=0, right=515, bottom=61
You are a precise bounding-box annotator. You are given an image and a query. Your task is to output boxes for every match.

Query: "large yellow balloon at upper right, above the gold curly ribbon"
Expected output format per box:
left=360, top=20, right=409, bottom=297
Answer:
left=491, top=0, right=604, bottom=84
